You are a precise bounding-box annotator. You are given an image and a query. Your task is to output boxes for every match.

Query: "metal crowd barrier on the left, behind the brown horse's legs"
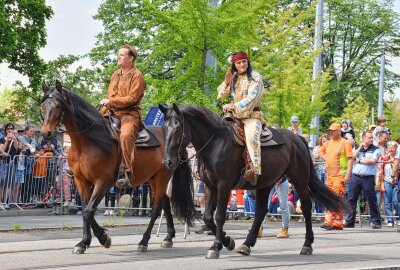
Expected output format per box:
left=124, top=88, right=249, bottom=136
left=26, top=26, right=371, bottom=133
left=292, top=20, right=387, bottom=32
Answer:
left=0, top=155, right=152, bottom=214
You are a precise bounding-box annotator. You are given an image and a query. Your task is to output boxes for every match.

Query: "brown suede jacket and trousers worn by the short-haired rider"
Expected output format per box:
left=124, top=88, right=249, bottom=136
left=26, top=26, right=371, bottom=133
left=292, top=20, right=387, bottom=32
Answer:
left=107, top=66, right=146, bottom=182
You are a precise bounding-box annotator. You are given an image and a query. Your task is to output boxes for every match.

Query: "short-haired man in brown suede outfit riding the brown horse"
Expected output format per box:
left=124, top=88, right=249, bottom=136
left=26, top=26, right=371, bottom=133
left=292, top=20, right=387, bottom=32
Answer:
left=100, top=45, right=146, bottom=187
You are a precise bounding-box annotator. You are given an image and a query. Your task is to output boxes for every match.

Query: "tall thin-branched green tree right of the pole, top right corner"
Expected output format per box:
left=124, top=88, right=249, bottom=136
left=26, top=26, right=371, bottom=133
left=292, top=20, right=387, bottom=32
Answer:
left=323, top=0, right=400, bottom=127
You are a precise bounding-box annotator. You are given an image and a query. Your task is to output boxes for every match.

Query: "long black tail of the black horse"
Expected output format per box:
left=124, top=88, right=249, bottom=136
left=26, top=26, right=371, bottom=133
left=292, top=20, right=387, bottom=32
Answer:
left=300, top=136, right=347, bottom=212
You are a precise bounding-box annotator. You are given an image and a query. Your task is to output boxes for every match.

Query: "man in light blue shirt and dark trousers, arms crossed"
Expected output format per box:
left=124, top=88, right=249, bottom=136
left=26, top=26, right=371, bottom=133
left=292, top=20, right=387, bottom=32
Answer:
left=345, top=131, right=381, bottom=229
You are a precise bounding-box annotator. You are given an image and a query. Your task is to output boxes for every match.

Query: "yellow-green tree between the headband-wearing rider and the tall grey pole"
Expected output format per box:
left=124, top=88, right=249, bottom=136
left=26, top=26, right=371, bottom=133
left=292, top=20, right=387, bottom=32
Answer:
left=254, top=2, right=329, bottom=133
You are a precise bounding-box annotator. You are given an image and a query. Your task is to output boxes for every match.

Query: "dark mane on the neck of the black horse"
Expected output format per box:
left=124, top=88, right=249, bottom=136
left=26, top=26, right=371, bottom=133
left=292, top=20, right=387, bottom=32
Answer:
left=179, top=105, right=233, bottom=135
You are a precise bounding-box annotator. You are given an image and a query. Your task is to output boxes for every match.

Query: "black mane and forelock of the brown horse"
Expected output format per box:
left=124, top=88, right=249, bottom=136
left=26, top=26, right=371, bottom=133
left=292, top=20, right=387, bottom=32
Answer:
left=42, top=87, right=112, bottom=155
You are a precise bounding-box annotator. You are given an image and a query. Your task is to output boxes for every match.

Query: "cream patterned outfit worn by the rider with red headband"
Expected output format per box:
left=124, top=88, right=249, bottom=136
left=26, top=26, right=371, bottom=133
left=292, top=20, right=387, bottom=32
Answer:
left=217, top=55, right=264, bottom=185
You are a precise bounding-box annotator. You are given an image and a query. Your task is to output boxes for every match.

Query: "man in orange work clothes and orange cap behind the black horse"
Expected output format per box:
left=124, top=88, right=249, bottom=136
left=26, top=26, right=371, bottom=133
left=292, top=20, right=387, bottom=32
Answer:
left=320, top=123, right=353, bottom=230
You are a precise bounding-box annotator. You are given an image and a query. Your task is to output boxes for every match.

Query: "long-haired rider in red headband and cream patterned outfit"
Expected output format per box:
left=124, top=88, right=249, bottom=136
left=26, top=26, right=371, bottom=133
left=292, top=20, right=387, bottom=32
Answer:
left=217, top=52, right=265, bottom=186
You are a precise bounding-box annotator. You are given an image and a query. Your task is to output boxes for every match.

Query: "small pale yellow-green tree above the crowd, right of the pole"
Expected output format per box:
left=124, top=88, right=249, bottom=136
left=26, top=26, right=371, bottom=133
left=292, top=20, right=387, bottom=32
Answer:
left=331, top=96, right=371, bottom=142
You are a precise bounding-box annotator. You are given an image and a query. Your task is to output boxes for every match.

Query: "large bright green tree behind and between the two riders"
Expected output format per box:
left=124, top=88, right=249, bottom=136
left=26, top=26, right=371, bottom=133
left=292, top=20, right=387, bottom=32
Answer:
left=90, top=0, right=273, bottom=108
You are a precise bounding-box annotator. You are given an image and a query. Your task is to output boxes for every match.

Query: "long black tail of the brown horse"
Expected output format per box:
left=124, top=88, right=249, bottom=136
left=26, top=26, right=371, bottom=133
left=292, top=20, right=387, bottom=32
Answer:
left=171, top=152, right=197, bottom=227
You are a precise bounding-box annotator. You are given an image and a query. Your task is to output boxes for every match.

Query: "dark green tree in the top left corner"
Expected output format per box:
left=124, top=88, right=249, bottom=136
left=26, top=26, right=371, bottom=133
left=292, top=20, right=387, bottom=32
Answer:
left=0, top=0, right=53, bottom=88
